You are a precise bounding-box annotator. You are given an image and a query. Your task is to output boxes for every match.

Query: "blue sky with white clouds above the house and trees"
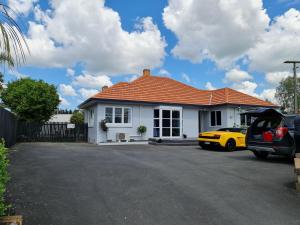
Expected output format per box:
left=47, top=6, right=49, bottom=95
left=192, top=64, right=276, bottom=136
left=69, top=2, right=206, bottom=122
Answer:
left=5, top=0, right=300, bottom=108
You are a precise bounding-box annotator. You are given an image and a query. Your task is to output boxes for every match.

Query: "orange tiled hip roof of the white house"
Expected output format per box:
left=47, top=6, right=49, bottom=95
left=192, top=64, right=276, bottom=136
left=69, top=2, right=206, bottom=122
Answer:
left=85, top=73, right=277, bottom=107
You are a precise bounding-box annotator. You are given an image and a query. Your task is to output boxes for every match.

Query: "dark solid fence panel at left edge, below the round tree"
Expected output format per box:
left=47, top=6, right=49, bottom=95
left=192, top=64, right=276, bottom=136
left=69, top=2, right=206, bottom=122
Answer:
left=0, top=108, right=18, bottom=147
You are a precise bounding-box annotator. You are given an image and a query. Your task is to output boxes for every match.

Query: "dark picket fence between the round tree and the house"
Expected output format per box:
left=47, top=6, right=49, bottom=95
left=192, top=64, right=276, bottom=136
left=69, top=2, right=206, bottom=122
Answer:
left=17, top=122, right=88, bottom=142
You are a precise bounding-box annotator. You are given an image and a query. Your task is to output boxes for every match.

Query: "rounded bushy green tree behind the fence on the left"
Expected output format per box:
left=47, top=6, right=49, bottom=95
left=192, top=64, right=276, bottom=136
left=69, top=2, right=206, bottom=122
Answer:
left=2, top=78, right=60, bottom=122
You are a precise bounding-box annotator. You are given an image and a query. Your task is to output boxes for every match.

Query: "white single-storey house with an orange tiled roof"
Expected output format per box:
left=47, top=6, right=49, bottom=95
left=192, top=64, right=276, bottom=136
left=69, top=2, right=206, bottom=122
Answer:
left=79, top=70, right=277, bottom=143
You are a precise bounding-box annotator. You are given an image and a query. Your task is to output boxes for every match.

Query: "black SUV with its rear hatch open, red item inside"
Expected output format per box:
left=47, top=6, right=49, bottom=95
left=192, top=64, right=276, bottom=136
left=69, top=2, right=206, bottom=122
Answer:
left=245, top=109, right=300, bottom=158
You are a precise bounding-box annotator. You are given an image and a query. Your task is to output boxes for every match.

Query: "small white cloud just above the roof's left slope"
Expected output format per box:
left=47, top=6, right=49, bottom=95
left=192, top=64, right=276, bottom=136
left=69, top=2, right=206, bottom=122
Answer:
left=72, top=74, right=112, bottom=90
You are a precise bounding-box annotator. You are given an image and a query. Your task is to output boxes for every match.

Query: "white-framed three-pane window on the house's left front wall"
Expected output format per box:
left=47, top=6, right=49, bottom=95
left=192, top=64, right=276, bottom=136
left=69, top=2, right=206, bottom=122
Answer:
left=105, top=107, right=132, bottom=125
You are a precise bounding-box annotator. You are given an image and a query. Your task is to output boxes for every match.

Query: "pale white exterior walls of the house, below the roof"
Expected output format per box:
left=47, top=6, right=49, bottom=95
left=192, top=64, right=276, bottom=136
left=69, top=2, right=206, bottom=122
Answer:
left=85, top=103, right=262, bottom=143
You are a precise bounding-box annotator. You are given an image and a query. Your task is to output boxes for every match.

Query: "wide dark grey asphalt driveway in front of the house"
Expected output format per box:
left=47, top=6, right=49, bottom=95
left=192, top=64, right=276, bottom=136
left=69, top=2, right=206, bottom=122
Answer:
left=5, top=143, right=300, bottom=225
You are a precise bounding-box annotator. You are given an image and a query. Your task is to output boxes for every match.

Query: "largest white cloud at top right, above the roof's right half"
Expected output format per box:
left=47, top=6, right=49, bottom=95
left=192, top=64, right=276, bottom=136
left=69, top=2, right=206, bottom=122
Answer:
left=163, top=0, right=270, bottom=67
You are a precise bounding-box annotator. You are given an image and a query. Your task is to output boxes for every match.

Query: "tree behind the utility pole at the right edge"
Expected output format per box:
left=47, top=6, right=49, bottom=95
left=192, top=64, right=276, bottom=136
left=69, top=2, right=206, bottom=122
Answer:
left=275, top=77, right=300, bottom=112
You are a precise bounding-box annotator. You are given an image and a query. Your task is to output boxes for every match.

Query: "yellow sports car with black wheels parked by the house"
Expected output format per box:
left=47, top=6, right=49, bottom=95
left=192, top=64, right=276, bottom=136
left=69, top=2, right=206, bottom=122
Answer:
left=198, top=128, right=246, bottom=151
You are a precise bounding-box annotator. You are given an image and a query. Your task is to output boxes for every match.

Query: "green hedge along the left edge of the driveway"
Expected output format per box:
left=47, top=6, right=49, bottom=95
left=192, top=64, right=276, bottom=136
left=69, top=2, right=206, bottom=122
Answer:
left=0, top=140, right=9, bottom=216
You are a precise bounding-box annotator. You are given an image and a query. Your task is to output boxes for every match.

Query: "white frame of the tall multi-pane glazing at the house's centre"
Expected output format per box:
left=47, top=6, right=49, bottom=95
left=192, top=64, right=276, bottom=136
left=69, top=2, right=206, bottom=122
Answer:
left=152, top=106, right=183, bottom=139
